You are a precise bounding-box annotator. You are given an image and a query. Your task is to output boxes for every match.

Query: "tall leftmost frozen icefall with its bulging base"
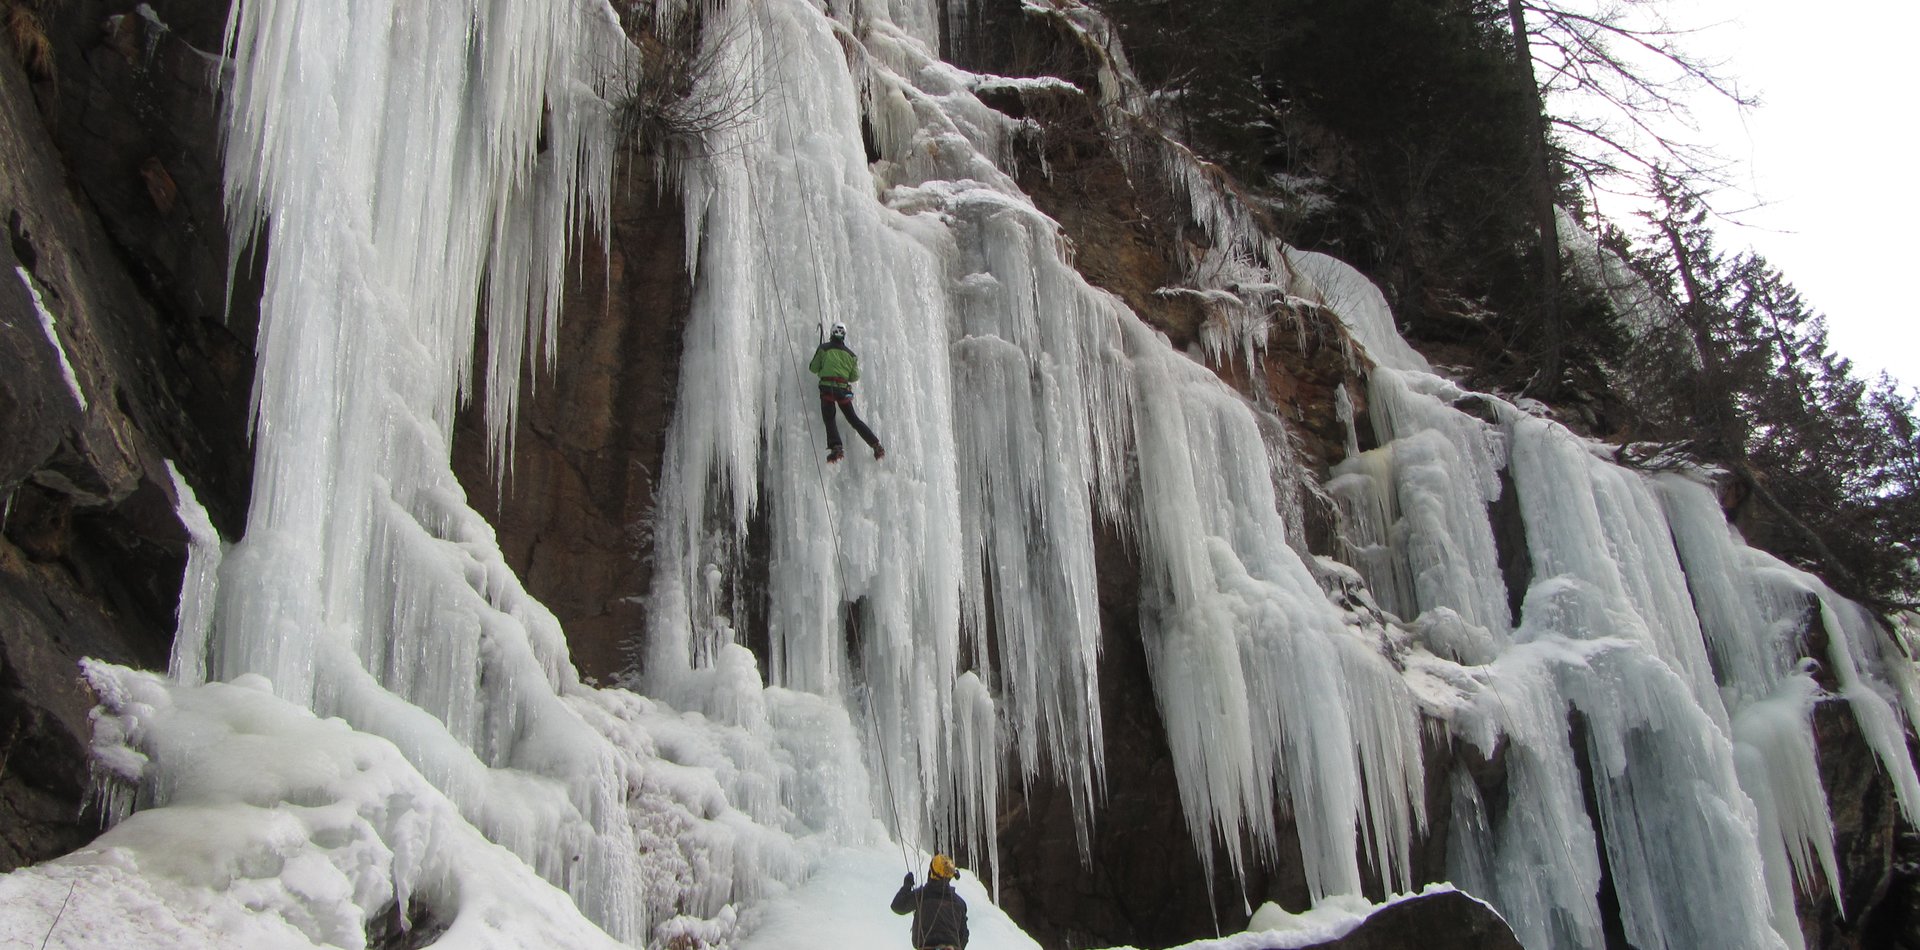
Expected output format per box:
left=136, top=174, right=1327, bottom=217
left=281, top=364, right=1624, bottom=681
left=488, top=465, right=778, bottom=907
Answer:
left=71, top=0, right=872, bottom=946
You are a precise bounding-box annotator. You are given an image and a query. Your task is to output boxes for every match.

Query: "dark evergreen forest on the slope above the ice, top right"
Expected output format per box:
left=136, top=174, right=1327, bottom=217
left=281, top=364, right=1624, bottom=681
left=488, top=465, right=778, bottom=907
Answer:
left=1104, top=0, right=1920, bottom=610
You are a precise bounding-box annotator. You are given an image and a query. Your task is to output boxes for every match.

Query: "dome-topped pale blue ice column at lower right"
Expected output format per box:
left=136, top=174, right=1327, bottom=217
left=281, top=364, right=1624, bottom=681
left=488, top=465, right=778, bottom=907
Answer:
left=1450, top=633, right=1791, bottom=948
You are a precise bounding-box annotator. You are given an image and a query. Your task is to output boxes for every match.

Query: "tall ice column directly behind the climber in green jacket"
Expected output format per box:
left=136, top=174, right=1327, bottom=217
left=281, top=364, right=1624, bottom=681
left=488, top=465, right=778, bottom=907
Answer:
left=645, top=2, right=1006, bottom=871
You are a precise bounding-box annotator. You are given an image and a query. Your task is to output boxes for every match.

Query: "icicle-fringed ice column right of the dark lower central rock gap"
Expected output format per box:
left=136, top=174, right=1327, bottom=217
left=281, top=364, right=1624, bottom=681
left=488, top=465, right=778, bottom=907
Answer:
left=1129, top=330, right=1425, bottom=898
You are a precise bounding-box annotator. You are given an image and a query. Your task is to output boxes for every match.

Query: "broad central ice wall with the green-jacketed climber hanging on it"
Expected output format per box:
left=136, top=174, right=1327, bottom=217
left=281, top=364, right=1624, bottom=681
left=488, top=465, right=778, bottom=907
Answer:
left=643, top=2, right=1425, bottom=894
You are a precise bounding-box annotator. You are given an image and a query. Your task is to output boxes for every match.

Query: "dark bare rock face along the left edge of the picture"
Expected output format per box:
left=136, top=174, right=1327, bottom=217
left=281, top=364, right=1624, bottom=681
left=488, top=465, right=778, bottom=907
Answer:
left=0, top=2, right=253, bottom=869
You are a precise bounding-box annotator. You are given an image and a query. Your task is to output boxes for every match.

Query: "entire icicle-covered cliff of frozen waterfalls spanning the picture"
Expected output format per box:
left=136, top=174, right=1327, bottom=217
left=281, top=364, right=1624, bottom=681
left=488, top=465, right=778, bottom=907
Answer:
left=0, top=0, right=1920, bottom=948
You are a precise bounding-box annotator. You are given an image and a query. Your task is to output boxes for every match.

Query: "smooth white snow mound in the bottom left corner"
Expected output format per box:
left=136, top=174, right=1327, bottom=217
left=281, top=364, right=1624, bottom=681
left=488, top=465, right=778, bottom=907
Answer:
left=0, top=662, right=622, bottom=950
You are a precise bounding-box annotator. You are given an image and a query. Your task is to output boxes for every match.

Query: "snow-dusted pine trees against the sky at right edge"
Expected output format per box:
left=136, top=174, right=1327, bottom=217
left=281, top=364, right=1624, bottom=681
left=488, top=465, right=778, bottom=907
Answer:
left=1620, top=178, right=1920, bottom=606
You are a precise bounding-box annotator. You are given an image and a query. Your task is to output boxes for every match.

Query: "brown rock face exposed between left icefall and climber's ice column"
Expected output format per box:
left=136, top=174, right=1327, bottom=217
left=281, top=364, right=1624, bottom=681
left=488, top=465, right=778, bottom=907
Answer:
left=453, top=178, right=691, bottom=681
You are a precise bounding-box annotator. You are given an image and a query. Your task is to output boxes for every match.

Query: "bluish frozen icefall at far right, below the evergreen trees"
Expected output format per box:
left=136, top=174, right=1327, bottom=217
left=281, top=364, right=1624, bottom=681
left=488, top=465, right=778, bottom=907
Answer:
left=1329, top=367, right=1914, bottom=948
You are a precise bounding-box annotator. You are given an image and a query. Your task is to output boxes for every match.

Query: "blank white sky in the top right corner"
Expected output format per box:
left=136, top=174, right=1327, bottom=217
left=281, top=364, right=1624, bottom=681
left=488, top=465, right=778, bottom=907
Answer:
left=1665, top=0, right=1920, bottom=390
